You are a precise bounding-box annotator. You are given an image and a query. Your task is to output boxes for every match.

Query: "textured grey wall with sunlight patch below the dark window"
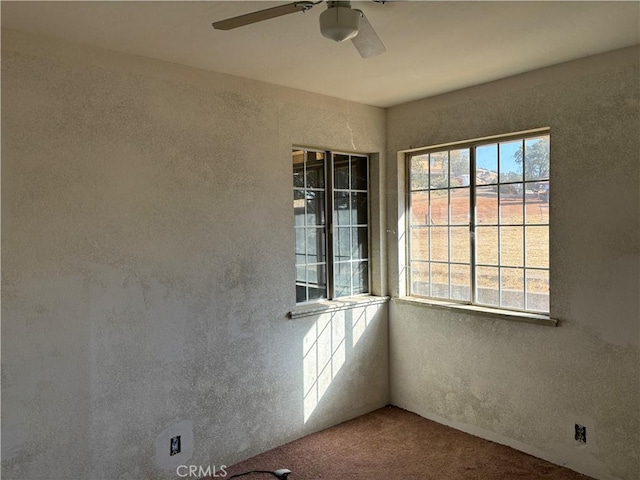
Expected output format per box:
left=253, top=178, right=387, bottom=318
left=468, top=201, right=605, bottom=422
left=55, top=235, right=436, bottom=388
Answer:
left=2, top=30, right=388, bottom=479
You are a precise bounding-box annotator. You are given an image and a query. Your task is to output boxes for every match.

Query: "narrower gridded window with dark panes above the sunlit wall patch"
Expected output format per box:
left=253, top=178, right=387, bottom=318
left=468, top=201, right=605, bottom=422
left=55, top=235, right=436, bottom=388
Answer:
left=293, top=148, right=369, bottom=303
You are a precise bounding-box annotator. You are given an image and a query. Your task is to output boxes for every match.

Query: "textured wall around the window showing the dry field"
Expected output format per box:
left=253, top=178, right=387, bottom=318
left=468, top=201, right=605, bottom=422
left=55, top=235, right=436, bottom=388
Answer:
left=388, top=48, right=640, bottom=480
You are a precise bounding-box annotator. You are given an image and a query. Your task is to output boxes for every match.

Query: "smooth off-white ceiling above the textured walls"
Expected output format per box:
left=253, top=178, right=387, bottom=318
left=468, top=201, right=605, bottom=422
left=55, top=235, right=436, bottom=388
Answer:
left=2, top=0, right=640, bottom=107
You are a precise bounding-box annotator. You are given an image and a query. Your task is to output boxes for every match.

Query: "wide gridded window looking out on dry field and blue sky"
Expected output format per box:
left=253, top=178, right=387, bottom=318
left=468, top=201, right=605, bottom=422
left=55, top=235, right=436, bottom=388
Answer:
left=407, top=132, right=550, bottom=313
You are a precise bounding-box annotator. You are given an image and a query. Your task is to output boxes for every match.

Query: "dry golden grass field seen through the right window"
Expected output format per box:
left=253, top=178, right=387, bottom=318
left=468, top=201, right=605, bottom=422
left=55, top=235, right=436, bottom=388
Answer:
left=410, top=185, right=549, bottom=308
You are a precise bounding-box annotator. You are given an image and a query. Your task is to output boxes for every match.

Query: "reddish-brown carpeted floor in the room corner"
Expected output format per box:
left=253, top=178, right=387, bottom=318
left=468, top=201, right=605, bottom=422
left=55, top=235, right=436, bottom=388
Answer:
left=212, top=407, right=590, bottom=480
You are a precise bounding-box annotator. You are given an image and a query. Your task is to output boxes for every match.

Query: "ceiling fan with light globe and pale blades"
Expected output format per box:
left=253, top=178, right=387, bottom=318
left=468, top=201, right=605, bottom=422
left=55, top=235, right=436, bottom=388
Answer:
left=212, top=1, right=387, bottom=58
